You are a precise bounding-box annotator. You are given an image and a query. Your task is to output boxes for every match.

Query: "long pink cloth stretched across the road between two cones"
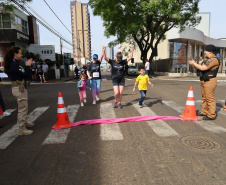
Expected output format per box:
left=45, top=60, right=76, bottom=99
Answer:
left=72, top=115, right=187, bottom=126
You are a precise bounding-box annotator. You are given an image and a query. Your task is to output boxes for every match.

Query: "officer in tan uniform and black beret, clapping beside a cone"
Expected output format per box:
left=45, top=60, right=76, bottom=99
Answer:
left=188, top=45, right=220, bottom=120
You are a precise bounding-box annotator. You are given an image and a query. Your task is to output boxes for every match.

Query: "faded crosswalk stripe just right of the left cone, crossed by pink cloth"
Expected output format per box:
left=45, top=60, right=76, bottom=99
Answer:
left=42, top=104, right=79, bottom=145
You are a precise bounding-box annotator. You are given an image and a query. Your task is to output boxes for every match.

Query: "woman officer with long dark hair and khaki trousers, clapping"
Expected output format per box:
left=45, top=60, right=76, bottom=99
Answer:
left=4, top=47, right=35, bottom=135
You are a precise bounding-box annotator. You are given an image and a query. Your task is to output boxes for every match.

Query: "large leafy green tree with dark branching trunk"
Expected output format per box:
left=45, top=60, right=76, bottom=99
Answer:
left=89, top=0, right=201, bottom=62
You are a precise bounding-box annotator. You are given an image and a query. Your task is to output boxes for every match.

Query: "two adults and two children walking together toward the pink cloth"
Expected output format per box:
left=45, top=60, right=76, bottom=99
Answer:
left=77, top=46, right=153, bottom=108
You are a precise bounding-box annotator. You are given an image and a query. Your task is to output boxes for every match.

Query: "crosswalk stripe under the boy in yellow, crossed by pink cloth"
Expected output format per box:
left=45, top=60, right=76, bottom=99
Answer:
left=132, top=102, right=179, bottom=137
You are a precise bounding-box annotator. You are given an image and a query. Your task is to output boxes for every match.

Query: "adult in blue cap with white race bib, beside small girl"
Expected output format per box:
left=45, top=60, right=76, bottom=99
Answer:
left=87, top=54, right=103, bottom=104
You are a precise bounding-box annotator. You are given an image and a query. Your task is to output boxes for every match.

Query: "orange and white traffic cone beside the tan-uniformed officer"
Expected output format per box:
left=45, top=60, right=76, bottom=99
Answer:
left=179, top=86, right=201, bottom=120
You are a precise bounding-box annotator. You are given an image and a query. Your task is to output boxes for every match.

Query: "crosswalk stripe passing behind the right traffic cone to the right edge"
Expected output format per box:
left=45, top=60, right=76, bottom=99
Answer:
left=162, top=101, right=226, bottom=134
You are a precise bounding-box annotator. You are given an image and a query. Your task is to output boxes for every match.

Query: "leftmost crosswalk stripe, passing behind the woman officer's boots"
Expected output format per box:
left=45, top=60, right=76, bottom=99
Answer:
left=0, top=107, right=49, bottom=149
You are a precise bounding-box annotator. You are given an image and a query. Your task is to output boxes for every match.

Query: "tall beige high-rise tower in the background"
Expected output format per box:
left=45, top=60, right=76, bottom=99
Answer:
left=71, top=1, right=91, bottom=65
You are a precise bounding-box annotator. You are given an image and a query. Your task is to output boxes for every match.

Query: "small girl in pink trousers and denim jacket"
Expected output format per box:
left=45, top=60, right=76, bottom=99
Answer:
left=77, top=74, right=91, bottom=107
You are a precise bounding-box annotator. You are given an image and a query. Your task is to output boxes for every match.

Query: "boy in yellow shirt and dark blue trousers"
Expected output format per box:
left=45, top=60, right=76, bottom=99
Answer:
left=133, top=66, right=153, bottom=108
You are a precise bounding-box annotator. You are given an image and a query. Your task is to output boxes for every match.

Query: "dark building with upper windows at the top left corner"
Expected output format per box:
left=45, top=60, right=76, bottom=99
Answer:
left=0, top=9, right=39, bottom=65
